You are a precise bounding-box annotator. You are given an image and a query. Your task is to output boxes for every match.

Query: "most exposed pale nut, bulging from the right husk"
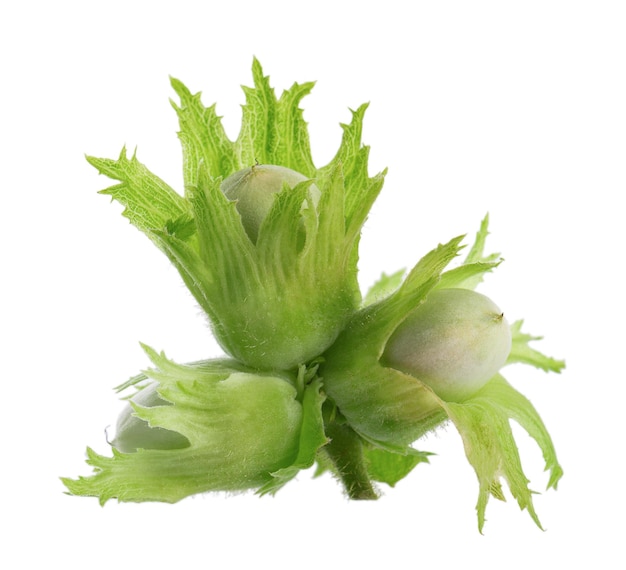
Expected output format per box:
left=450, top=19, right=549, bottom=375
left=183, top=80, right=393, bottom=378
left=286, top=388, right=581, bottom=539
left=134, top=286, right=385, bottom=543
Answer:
left=382, top=289, right=511, bottom=401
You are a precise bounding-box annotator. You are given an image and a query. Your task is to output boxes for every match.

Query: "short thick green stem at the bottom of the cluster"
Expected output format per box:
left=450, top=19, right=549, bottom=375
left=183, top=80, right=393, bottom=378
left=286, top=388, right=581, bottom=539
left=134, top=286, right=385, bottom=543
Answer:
left=324, top=421, right=378, bottom=500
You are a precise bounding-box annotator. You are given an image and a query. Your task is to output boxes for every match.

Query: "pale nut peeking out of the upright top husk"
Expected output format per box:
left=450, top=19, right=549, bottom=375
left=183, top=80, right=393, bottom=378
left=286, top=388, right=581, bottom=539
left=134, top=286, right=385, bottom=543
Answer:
left=221, top=164, right=321, bottom=243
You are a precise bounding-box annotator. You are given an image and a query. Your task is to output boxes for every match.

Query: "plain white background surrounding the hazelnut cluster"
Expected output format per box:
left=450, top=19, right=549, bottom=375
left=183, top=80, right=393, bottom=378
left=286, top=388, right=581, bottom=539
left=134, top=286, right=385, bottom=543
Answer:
left=0, top=0, right=626, bottom=570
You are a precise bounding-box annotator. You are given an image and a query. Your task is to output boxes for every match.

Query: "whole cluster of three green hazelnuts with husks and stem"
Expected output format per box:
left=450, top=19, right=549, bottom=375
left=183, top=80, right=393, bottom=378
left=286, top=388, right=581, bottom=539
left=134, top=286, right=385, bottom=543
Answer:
left=63, top=60, right=563, bottom=529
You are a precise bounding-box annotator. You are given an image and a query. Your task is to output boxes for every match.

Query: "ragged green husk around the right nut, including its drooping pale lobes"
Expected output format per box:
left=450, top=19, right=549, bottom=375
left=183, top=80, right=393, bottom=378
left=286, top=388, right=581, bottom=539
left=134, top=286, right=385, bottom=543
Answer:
left=320, top=218, right=564, bottom=531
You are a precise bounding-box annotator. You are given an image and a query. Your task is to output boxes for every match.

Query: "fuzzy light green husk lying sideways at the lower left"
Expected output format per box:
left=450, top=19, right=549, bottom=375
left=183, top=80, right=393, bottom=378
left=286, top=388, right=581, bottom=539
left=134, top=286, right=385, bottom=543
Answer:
left=63, top=347, right=326, bottom=504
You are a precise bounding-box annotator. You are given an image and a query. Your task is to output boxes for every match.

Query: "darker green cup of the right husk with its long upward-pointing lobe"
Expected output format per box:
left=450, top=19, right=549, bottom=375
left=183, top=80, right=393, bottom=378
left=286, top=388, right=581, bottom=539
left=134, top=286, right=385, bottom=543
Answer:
left=320, top=237, right=462, bottom=453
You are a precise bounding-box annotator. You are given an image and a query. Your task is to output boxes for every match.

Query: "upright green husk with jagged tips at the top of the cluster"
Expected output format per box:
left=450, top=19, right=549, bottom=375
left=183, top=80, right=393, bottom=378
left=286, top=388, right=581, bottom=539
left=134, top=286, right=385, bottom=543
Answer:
left=88, top=60, right=384, bottom=370
